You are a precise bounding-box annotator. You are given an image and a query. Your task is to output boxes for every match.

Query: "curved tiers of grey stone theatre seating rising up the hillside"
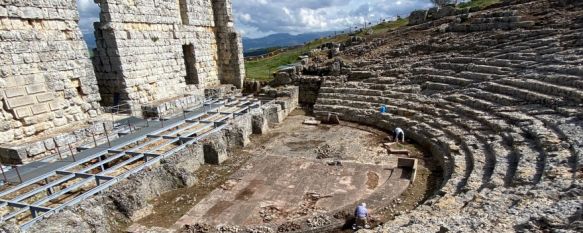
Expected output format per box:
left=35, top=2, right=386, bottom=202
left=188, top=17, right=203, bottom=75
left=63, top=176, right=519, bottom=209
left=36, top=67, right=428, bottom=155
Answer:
left=314, top=1, right=583, bottom=232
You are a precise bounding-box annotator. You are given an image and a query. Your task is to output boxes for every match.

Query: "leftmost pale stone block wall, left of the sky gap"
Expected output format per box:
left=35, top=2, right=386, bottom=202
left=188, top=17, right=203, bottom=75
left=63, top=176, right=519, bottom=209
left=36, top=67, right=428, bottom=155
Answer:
left=0, top=0, right=100, bottom=144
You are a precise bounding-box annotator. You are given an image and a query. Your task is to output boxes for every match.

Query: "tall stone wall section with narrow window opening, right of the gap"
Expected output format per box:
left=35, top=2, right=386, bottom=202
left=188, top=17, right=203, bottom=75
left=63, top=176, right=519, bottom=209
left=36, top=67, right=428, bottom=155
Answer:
left=93, top=0, right=244, bottom=115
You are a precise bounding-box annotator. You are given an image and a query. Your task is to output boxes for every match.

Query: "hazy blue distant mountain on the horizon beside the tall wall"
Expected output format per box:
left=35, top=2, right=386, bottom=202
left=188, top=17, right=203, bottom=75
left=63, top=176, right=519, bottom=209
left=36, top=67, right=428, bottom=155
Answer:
left=243, top=32, right=334, bottom=52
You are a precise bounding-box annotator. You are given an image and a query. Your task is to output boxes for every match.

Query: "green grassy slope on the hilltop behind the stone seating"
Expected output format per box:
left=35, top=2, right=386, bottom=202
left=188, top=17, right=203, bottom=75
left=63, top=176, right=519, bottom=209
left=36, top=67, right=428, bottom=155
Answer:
left=245, top=19, right=408, bottom=81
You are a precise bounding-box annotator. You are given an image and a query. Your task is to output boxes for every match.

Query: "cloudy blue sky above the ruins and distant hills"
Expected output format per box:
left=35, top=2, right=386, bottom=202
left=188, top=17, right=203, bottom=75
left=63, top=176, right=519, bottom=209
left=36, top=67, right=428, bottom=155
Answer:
left=77, top=0, right=432, bottom=38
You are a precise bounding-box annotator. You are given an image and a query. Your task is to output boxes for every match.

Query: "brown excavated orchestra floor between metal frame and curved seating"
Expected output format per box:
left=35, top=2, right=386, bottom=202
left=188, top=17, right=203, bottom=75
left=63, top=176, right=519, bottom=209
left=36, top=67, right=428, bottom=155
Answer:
left=127, top=110, right=442, bottom=232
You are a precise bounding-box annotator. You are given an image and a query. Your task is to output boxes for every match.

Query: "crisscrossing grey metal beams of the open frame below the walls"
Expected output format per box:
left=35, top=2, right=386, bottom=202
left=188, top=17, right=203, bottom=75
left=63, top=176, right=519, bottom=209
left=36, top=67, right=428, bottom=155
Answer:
left=0, top=96, right=261, bottom=229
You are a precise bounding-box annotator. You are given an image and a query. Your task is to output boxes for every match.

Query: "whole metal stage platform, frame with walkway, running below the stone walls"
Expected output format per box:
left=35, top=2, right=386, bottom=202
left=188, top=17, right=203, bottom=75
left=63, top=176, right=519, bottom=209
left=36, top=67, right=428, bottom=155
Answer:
left=0, top=96, right=261, bottom=230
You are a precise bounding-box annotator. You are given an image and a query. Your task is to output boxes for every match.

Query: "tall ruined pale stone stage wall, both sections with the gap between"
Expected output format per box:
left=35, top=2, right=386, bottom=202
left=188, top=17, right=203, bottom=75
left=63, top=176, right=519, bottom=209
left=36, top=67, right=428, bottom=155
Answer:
left=0, top=0, right=244, bottom=164
